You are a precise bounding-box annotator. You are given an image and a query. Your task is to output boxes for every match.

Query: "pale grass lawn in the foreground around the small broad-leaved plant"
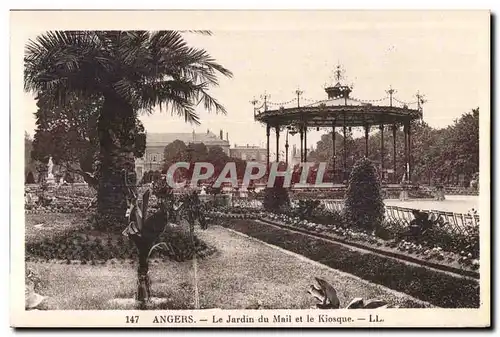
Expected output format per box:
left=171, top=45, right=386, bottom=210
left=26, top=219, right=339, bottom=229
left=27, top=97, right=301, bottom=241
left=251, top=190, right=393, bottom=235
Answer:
left=28, top=226, right=432, bottom=310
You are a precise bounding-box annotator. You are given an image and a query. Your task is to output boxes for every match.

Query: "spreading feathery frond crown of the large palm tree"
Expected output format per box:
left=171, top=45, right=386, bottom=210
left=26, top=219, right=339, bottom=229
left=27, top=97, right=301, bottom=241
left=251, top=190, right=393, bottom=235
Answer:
left=24, top=30, right=232, bottom=122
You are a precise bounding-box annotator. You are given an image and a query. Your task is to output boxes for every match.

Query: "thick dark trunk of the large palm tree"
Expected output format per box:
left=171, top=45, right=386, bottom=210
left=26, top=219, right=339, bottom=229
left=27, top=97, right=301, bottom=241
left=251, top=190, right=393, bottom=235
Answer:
left=97, top=96, right=136, bottom=230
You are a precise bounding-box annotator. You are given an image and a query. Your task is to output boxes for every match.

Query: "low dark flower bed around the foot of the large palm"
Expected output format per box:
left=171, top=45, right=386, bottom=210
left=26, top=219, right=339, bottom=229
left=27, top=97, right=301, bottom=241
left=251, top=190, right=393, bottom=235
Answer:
left=25, top=213, right=214, bottom=264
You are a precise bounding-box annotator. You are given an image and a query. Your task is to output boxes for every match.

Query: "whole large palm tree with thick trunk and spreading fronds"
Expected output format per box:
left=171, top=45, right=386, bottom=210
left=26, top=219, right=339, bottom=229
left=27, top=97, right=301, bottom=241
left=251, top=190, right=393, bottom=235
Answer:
left=24, top=31, right=232, bottom=225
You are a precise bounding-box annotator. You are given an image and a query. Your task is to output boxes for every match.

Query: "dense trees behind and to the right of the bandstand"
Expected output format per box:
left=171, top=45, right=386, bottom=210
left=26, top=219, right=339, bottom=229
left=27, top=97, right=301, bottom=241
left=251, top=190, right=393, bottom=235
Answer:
left=308, top=108, right=479, bottom=184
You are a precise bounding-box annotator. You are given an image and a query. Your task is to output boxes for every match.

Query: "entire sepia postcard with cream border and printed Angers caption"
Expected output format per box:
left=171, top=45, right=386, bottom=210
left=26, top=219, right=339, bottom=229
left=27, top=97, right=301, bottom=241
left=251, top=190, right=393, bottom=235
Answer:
left=10, top=10, right=491, bottom=328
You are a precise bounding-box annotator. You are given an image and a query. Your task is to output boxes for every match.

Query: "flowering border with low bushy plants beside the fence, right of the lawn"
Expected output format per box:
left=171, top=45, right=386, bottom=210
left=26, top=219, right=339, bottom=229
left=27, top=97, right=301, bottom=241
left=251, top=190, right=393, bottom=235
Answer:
left=211, top=203, right=479, bottom=275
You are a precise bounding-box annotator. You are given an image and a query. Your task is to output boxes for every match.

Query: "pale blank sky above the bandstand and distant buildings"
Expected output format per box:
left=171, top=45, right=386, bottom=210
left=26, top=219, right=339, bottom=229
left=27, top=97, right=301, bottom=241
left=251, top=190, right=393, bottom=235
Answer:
left=24, top=12, right=489, bottom=155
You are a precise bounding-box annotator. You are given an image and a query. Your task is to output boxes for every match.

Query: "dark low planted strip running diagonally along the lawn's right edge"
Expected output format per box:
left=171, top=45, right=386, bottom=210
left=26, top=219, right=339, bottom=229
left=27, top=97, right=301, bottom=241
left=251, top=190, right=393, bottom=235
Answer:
left=223, top=219, right=479, bottom=308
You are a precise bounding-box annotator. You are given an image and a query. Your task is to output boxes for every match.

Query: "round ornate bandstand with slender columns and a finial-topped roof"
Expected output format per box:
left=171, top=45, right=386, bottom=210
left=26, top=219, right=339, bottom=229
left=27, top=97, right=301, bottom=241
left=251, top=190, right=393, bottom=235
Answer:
left=251, top=66, right=425, bottom=196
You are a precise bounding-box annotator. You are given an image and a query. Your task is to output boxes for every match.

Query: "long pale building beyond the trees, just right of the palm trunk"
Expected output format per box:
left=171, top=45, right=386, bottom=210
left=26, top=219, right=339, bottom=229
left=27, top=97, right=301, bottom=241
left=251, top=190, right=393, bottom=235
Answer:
left=135, top=130, right=230, bottom=180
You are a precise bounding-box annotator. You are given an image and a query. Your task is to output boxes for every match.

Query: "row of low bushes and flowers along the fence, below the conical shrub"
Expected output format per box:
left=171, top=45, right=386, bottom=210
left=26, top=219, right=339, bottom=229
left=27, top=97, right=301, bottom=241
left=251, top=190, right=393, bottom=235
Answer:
left=217, top=200, right=479, bottom=262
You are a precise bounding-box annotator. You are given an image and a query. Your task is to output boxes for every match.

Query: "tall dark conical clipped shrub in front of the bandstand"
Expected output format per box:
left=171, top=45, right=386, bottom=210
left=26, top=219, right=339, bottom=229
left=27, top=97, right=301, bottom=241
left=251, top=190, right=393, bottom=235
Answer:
left=344, top=158, right=384, bottom=231
